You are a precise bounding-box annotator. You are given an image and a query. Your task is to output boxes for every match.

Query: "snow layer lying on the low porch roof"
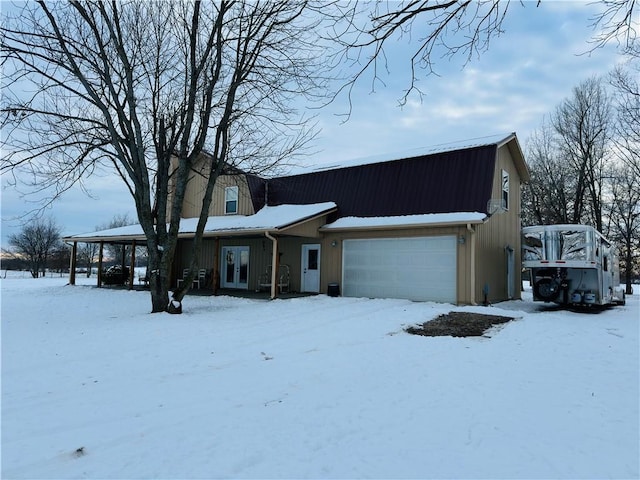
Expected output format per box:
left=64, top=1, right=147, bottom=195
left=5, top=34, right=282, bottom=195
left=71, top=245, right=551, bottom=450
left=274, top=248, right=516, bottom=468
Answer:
left=65, top=202, right=337, bottom=240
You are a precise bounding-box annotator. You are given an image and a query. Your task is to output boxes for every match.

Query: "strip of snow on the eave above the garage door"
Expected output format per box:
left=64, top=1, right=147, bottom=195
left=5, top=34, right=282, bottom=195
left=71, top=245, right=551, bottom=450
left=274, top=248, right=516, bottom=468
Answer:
left=322, top=212, right=487, bottom=230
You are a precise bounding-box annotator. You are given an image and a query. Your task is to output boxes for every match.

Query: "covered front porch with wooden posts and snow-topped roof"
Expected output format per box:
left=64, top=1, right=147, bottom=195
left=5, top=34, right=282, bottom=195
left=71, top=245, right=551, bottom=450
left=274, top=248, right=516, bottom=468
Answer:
left=63, top=202, right=337, bottom=298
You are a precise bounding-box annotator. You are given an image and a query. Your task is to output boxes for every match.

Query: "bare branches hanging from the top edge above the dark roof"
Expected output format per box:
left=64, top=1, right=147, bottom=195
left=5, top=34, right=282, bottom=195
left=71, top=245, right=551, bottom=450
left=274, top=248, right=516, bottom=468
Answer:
left=333, top=0, right=510, bottom=104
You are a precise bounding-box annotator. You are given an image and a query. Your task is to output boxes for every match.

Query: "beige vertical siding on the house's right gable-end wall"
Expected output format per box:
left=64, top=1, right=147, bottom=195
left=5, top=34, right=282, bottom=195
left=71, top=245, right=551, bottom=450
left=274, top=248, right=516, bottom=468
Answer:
left=475, top=146, right=521, bottom=303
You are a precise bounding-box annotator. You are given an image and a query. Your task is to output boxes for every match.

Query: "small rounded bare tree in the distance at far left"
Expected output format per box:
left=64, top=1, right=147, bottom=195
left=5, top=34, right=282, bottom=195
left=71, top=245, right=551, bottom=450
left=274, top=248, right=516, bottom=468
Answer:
left=9, top=218, right=60, bottom=278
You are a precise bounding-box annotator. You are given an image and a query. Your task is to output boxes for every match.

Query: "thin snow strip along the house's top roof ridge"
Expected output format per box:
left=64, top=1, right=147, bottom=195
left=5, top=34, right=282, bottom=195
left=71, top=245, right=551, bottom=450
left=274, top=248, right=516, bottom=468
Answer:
left=294, top=133, right=515, bottom=174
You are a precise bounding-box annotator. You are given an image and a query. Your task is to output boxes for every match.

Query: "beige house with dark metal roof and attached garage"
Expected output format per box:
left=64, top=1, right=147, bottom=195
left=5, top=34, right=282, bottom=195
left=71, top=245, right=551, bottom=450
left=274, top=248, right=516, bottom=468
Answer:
left=65, top=133, right=529, bottom=304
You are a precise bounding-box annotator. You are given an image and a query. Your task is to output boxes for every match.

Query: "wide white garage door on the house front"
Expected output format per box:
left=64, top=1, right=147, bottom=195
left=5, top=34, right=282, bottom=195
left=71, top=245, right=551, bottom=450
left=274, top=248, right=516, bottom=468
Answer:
left=342, top=236, right=457, bottom=303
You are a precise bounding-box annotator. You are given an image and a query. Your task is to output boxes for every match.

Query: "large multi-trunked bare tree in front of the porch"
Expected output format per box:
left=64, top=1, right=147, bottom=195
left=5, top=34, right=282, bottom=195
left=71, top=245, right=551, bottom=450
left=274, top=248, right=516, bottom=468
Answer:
left=2, top=0, right=325, bottom=312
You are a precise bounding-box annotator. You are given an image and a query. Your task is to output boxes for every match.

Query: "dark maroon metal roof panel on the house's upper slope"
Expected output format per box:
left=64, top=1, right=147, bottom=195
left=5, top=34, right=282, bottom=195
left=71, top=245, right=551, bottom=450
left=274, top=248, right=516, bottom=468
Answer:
left=268, top=145, right=497, bottom=217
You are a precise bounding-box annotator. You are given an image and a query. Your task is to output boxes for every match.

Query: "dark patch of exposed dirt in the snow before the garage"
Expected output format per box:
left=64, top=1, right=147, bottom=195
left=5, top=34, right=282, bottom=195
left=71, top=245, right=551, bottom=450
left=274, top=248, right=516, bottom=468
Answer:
left=406, top=312, right=513, bottom=337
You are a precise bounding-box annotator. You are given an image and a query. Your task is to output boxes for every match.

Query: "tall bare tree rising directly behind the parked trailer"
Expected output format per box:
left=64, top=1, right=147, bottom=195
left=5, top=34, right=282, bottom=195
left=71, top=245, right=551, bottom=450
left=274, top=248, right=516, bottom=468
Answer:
left=524, top=77, right=613, bottom=234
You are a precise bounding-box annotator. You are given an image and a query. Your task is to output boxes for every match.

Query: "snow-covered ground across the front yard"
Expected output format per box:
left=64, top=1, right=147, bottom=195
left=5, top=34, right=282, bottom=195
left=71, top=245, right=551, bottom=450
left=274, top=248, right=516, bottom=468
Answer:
left=0, top=277, right=640, bottom=479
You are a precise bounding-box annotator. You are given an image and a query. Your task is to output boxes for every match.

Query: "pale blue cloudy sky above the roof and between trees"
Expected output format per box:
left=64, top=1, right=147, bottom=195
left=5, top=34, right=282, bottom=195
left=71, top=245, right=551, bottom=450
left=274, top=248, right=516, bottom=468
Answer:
left=1, top=0, right=622, bottom=248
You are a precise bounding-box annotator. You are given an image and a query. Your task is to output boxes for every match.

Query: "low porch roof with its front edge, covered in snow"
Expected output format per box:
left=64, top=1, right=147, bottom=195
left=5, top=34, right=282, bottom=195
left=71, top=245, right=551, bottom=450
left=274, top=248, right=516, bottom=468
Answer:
left=63, top=202, right=337, bottom=243
